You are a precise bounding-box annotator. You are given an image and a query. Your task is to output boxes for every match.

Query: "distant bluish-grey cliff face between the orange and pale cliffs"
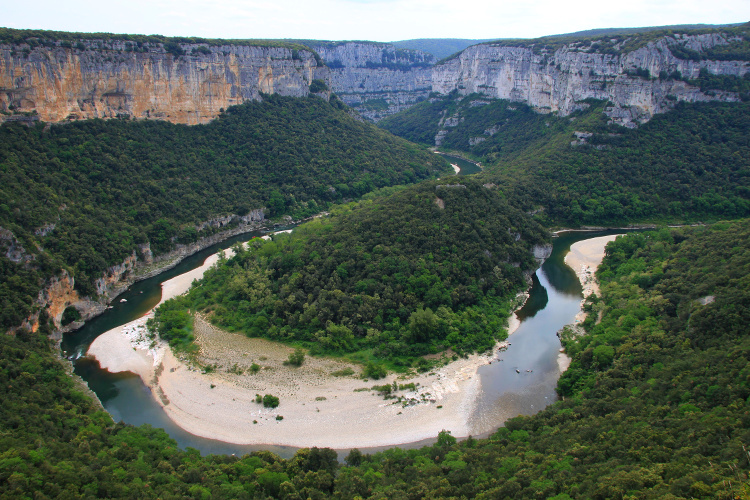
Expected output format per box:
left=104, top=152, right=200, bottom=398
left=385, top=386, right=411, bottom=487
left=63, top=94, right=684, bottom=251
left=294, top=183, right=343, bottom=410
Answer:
left=311, top=42, right=435, bottom=122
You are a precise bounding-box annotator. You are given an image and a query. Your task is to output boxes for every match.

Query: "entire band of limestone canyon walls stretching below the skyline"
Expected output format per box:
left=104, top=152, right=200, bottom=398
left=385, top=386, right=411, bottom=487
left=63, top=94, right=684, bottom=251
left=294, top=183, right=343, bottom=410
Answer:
left=0, top=30, right=748, bottom=126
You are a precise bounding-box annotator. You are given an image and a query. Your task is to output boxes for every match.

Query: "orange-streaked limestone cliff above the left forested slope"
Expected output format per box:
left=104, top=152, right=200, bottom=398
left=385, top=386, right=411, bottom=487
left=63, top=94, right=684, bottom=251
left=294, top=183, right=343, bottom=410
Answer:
left=0, top=39, right=328, bottom=124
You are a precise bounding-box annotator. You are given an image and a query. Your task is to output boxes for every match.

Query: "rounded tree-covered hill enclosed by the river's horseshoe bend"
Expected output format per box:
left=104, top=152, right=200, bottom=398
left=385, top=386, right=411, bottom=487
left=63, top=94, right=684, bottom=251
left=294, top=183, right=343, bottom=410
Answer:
left=156, top=182, right=548, bottom=367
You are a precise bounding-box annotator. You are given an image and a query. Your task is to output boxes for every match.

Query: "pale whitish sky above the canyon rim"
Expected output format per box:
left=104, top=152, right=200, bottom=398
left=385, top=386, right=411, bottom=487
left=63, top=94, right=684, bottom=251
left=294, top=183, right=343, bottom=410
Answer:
left=0, top=0, right=750, bottom=42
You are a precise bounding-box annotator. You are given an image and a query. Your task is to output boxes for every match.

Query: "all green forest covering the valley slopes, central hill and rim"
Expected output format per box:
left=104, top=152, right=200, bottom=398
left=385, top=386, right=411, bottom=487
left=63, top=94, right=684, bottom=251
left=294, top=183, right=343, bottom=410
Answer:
left=0, top=25, right=750, bottom=500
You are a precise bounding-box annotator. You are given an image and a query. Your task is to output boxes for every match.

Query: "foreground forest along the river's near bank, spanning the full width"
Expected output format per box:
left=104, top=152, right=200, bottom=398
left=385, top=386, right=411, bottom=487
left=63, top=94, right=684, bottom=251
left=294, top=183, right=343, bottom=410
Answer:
left=0, top=220, right=750, bottom=499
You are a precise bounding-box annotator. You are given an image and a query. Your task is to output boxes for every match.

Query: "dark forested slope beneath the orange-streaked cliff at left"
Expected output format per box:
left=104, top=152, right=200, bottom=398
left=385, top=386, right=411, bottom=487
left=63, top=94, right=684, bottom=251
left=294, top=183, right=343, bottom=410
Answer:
left=0, top=95, right=449, bottom=329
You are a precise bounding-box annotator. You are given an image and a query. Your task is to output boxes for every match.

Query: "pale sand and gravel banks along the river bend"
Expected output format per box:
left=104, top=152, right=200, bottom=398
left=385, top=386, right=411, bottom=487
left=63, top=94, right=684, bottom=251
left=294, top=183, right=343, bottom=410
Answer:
left=88, top=237, right=613, bottom=449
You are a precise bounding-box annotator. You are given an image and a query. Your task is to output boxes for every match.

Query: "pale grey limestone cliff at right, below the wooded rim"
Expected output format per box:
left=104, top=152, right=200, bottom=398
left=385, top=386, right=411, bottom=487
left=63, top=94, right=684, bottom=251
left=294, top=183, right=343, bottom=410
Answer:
left=432, top=33, right=750, bottom=126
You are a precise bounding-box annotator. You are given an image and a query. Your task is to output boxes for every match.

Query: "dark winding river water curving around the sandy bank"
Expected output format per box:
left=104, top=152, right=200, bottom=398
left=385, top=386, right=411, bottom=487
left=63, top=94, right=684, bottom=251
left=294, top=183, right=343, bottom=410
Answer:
left=61, top=231, right=622, bottom=457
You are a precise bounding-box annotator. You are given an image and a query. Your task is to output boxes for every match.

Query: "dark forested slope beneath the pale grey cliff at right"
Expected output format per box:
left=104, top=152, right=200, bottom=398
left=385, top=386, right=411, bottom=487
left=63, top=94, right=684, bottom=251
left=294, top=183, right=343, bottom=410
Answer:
left=496, top=103, right=750, bottom=225
